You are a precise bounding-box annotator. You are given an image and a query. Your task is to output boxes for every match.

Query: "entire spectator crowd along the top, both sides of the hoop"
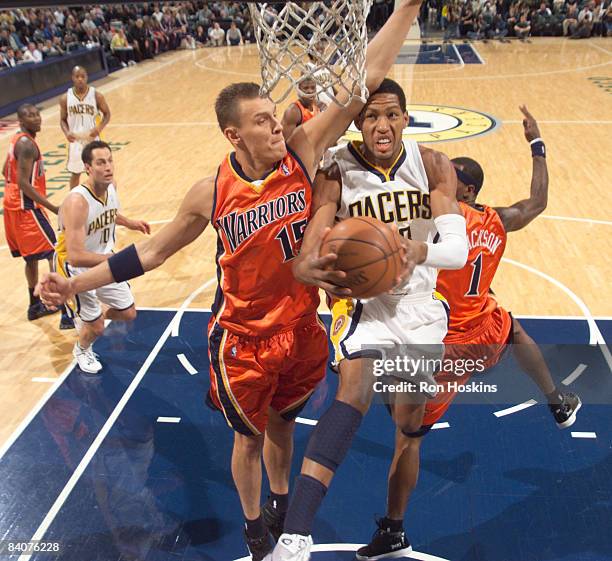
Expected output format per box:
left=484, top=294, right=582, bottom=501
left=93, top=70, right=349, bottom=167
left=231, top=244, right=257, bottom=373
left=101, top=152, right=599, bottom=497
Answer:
left=0, top=0, right=612, bottom=69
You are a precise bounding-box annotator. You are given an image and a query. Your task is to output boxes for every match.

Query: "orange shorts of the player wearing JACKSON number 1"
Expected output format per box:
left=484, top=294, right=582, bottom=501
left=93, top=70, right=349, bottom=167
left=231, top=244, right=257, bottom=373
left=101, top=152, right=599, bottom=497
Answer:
left=423, top=306, right=512, bottom=426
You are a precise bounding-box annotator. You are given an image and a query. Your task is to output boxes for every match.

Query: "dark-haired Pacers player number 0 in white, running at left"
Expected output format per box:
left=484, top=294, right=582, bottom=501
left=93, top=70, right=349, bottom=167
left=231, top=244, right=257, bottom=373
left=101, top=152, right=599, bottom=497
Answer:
left=55, top=140, right=151, bottom=374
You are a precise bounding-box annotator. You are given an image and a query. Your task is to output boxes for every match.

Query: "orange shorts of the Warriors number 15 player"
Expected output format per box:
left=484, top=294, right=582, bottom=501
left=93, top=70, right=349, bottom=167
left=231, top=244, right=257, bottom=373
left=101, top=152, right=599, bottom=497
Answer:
left=207, top=316, right=328, bottom=436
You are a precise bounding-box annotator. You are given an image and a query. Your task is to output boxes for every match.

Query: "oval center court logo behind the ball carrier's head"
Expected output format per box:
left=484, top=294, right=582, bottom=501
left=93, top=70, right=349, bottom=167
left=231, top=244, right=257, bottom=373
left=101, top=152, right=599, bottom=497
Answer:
left=344, top=104, right=499, bottom=142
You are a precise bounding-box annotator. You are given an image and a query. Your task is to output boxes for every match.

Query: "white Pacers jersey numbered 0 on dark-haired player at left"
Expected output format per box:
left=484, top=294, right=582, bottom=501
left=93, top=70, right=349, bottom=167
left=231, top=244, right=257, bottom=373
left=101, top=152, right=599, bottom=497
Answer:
left=56, top=183, right=119, bottom=260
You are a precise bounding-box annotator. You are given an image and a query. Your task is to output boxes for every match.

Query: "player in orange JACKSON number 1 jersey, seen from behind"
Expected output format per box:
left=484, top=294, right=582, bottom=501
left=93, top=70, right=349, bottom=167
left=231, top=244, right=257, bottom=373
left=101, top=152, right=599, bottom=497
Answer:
left=357, top=107, right=581, bottom=560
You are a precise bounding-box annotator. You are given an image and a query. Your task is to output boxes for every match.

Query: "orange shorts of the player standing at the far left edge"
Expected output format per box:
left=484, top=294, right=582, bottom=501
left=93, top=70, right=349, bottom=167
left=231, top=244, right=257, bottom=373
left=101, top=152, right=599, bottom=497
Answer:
left=4, top=208, right=56, bottom=261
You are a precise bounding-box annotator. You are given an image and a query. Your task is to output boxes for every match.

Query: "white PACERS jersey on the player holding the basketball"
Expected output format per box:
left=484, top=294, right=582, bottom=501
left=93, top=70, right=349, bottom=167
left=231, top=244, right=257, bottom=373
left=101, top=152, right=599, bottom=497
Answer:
left=333, top=140, right=438, bottom=295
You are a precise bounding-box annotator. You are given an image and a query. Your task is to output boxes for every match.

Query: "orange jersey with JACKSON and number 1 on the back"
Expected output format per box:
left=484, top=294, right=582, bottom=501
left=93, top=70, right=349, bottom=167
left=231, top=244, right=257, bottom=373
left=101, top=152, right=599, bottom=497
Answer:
left=437, top=203, right=506, bottom=341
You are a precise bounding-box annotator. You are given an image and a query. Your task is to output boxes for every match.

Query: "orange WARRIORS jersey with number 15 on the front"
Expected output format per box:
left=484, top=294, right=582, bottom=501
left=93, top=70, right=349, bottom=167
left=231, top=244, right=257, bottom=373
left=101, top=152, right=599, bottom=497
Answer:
left=211, top=147, right=319, bottom=337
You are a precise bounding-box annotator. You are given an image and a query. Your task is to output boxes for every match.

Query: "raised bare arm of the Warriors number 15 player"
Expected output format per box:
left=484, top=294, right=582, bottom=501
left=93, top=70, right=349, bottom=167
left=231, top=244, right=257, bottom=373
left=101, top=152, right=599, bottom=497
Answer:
left=287, top=0, right=422, bottom=177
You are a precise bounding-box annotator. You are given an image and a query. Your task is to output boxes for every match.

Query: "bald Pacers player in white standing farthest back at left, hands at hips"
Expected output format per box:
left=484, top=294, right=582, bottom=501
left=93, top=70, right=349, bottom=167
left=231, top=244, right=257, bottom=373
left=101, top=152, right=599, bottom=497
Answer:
left=60, top=66, right=110, bottom=189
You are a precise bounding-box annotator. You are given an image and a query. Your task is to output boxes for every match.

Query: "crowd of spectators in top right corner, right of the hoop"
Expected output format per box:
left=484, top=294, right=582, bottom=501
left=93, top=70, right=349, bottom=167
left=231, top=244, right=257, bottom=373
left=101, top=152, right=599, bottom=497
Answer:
left=421, top=0, right=612, bottom=41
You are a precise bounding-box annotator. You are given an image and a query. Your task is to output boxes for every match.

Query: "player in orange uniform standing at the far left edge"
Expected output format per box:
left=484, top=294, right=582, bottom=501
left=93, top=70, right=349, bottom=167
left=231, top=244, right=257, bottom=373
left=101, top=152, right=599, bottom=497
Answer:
left=3, top=104, right=68, bottom=321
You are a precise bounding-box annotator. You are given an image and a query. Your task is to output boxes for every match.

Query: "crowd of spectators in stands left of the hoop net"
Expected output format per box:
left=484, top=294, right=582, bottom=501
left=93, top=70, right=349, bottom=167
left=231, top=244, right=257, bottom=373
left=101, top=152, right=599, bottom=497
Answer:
left=0, top=1, right=254, bottom=69
